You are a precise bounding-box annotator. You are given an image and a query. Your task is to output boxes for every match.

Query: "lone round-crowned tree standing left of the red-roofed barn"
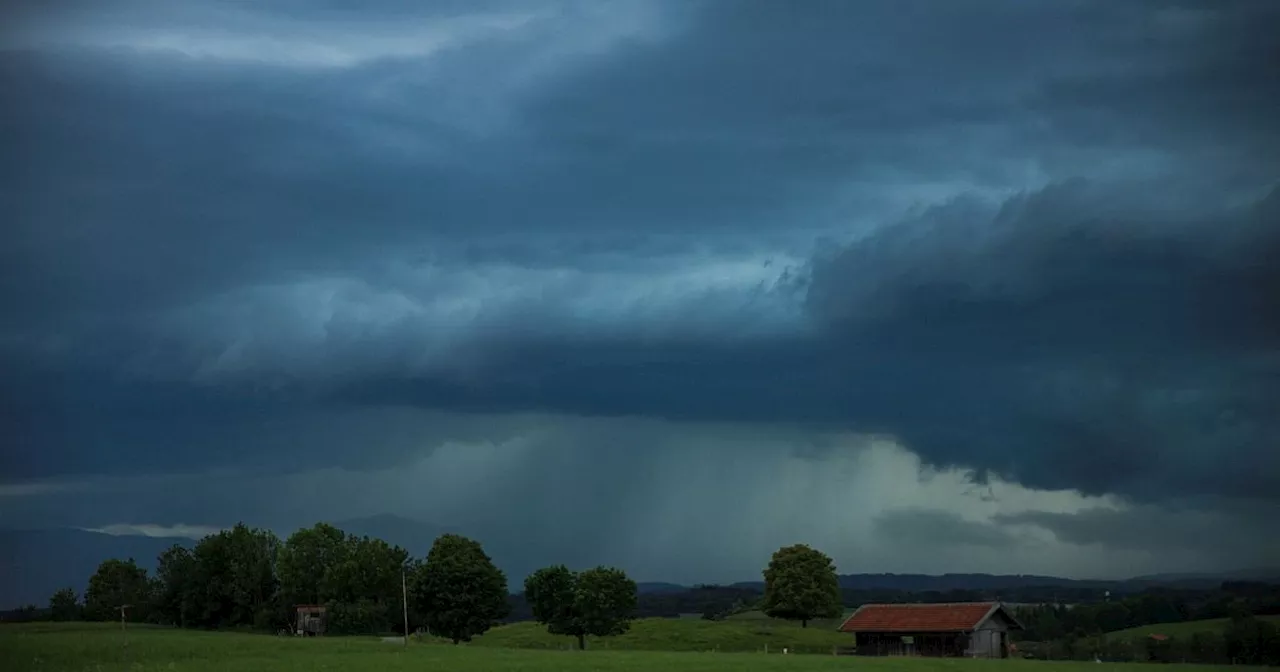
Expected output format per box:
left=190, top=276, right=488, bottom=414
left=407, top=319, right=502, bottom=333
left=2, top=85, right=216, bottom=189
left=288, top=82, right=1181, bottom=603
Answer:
left=764, top=544, right=842, bottom=627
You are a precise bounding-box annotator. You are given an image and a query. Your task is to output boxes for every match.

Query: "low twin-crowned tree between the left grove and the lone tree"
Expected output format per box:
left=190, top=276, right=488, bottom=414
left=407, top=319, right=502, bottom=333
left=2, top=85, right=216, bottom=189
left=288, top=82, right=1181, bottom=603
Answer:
left=525, top=564, right=636, bottom=649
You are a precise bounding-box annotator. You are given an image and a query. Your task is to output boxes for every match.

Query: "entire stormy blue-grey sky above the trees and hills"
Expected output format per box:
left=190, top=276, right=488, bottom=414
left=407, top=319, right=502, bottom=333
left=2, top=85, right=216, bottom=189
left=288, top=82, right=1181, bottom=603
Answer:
left=0, top=0, right=1280, bottom=581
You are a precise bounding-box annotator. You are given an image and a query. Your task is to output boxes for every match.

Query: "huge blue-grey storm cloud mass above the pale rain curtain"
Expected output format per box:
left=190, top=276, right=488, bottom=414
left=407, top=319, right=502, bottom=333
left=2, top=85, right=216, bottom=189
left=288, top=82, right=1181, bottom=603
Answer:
left=0, top=1, right=1280, bottom=529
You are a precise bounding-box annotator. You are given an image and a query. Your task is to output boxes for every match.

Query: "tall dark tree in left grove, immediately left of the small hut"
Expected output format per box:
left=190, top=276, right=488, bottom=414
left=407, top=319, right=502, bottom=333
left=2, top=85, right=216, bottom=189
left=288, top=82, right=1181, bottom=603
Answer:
left=192, top=524, right=280, bottom=630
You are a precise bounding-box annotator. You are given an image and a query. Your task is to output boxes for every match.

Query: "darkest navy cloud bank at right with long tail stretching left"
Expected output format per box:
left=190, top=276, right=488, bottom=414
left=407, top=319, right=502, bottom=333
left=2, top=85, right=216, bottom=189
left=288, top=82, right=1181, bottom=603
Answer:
left=332, top=183, right=1280, bottom=499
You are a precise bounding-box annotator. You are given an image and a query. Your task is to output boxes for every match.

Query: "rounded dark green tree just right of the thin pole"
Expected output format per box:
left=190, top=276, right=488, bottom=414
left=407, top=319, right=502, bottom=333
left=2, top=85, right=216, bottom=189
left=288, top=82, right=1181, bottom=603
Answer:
left=413, top=534, right=511, bottom=644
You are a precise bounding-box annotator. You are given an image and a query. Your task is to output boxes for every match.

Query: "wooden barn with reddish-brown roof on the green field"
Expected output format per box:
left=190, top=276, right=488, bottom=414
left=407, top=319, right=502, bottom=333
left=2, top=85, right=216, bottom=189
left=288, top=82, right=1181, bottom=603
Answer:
left=840, top=602, right=1023, bottom=658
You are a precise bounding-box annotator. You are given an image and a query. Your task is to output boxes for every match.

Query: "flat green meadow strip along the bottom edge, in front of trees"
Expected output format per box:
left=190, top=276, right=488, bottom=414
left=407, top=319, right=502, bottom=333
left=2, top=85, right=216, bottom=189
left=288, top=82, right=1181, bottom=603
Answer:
left=0, top=623, right=1259, bottom=672
